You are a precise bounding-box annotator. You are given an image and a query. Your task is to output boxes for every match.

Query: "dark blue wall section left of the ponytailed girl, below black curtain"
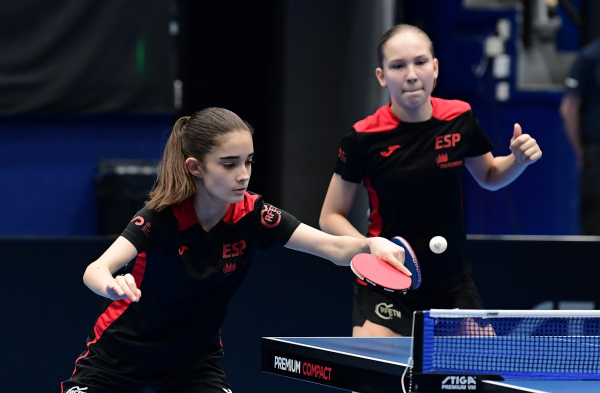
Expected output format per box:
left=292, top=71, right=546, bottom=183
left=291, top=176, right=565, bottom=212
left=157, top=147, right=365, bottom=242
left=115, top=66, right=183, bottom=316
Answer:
left=0, top=115, right=173, bottom=236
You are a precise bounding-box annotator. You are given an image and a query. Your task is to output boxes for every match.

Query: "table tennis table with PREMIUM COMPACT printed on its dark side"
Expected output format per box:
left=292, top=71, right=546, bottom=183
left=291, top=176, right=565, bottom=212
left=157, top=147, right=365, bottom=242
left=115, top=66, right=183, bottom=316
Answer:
left=261, top=337, right=600, bottom=393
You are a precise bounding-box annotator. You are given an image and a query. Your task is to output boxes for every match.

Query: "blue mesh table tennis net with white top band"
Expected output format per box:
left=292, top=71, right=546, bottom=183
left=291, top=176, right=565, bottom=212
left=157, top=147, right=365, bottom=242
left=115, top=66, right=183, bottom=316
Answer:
left=415, top=310, right=600, bottom=379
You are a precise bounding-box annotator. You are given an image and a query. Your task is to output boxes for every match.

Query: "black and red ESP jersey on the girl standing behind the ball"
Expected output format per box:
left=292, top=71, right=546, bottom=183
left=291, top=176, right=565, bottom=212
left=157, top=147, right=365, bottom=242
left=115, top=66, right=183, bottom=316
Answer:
left=335, top=97, right=493, bottom=289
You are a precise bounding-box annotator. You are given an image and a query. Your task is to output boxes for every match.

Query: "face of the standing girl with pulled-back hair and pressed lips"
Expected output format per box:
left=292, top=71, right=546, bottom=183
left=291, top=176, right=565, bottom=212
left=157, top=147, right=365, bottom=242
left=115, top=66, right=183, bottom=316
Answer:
left=377, top=31, right=438, bottom=110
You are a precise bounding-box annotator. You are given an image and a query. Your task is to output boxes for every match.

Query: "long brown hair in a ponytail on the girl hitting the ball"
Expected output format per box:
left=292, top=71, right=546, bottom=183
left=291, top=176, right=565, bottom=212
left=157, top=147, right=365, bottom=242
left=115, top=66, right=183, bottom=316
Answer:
left=146, top=108, right=253, bottom=211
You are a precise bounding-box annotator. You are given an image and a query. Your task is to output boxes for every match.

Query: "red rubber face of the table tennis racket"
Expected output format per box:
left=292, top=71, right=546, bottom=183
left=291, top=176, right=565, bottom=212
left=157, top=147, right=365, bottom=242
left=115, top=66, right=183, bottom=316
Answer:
left=350, top=254, right=412, bottom=292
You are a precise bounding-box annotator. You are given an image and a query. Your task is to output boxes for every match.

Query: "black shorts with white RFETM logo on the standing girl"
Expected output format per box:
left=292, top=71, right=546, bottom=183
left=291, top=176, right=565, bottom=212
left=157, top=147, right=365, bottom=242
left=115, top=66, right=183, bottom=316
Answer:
left=352, top=280, right=483, bottom=336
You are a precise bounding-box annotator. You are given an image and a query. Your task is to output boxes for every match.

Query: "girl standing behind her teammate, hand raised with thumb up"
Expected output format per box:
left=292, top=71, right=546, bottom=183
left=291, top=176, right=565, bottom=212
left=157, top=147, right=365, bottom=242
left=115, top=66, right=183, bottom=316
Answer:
left=320, top=25, right=542, bottom=336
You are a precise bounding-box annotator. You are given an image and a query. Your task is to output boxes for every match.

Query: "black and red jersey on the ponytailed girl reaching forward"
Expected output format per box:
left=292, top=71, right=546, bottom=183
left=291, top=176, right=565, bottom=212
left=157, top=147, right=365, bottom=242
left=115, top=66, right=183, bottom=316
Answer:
left=81, top=193, right=300, bottom=369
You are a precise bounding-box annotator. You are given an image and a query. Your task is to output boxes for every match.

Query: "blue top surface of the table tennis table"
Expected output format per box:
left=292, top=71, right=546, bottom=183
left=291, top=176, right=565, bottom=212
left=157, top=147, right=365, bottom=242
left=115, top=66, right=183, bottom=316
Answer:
left=269, top=337, right=600, bottom=393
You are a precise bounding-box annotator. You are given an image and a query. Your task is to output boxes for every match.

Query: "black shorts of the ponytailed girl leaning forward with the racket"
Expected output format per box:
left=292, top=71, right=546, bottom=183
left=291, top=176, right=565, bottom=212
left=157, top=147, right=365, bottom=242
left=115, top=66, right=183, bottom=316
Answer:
left=61, top=342, right=233, bottom=393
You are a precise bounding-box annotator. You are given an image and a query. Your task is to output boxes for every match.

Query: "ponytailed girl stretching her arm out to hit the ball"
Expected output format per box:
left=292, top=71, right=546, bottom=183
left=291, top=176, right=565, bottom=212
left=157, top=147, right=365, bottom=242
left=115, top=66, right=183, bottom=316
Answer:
left=62, top=108, right=406, bottom=393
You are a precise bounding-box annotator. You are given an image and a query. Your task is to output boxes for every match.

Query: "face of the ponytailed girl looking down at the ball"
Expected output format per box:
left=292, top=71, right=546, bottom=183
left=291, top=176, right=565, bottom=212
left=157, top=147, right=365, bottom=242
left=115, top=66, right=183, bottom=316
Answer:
left=200, top=130, right=254, bottom=203
